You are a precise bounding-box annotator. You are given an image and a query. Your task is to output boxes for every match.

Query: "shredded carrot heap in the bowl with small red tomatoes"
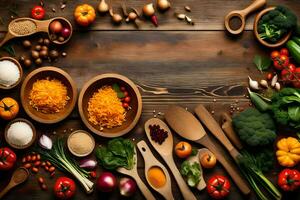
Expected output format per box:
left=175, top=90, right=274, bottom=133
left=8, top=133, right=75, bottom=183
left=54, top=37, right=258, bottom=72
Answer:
left=88, top=86, right=126, bottom=128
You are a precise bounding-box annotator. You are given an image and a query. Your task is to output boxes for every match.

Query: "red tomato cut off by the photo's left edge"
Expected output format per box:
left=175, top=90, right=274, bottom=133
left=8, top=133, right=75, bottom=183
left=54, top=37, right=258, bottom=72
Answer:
left=0, top=147, right=17, bottom=171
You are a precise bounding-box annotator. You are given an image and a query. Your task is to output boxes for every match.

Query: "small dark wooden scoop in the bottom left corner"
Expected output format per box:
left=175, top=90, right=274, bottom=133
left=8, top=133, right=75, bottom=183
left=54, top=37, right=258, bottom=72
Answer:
left=0, top=167, right=29, bottom=199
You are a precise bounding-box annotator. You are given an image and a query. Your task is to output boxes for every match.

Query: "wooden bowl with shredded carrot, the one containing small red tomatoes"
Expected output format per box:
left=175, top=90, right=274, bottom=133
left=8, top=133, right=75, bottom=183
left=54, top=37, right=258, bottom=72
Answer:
left=78, top=74, right=142, bottom=138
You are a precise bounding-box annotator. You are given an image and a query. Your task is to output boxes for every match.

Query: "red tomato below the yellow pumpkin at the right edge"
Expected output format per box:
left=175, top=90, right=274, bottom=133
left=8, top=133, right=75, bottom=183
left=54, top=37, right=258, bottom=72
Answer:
left=277, top=169, right=300, bottom=192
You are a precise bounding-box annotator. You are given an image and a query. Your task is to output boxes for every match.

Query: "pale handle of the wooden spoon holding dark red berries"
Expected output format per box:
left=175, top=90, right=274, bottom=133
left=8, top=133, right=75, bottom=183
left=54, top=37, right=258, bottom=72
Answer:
left=163, top=155, right=197, bottom=200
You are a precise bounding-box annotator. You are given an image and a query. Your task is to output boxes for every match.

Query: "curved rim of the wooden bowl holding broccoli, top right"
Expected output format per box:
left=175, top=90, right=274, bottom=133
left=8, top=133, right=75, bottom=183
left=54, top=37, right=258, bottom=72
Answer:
left=253, top=7, right=292, bottom=48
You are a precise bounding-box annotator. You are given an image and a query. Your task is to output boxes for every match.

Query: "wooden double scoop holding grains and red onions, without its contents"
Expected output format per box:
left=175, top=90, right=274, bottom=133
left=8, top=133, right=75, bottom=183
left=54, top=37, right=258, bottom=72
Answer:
left=0, top=17, right=73, bottom=47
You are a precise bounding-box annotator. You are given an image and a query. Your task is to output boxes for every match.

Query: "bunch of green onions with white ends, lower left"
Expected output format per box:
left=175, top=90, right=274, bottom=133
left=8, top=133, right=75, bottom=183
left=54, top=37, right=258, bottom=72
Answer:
left=38, top=138, right=94, bottom=193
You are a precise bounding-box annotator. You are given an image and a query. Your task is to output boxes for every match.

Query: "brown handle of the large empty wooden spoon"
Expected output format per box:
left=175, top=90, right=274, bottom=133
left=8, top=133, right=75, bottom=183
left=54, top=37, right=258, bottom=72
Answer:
left=195, top=135, right=250, bottom=195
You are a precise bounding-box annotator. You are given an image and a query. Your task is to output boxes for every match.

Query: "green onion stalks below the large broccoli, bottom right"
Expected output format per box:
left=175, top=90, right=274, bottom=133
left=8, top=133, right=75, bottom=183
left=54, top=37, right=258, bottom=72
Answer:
left=238, top=151, right=282, bottom=200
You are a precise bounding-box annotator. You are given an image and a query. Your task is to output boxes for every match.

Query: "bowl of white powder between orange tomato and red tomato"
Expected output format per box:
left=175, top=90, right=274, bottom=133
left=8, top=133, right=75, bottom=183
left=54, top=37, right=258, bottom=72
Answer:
left=4, top=118, right=36, bottom=149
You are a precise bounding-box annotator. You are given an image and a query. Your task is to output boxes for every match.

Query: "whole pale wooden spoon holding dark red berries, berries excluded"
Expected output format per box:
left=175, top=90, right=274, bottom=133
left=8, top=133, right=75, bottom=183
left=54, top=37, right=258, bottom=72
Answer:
left=145, top=118, right=196, bottom=200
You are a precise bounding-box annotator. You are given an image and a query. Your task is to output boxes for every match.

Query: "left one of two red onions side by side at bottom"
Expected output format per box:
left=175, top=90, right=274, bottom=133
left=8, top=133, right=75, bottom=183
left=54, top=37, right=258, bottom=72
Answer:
left=97, top=172, right=117, bottom=192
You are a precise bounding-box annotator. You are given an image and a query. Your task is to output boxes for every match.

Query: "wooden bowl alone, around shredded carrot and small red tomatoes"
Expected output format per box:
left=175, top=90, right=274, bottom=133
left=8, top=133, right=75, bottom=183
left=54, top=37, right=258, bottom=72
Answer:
left=78, top=74, right=142, bottom=138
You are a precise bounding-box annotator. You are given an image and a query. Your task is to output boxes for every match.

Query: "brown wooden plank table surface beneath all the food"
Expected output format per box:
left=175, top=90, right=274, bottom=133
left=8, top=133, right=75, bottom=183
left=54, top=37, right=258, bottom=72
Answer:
left=0, top=0, right=300, bottom=200
